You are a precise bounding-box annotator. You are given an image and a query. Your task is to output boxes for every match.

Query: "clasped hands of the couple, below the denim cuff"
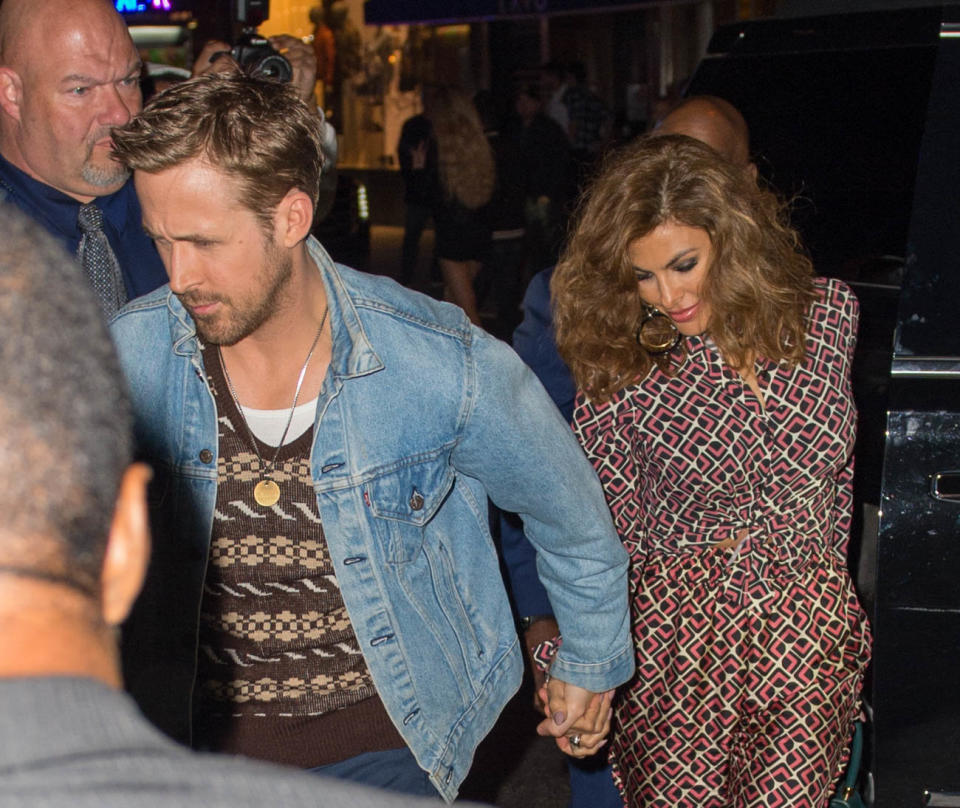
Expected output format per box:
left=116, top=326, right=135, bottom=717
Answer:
left=537, top=678, right=613, bottom=758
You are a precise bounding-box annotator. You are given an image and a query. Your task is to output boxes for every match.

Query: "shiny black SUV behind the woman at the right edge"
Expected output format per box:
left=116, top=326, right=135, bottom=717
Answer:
left=687, top=6, right=960, bottom=808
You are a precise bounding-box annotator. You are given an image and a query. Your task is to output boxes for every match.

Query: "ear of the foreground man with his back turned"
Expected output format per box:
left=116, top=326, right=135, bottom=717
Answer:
left=100, top=463, right=152, bottom=626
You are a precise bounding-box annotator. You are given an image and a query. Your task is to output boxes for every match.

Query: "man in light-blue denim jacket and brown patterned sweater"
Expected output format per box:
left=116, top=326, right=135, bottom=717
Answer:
left=112, top=76, right=633, bottom=801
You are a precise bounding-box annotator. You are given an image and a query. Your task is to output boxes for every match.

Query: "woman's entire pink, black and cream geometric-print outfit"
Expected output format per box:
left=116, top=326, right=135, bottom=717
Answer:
left=574, top=279, right=870, bottom=808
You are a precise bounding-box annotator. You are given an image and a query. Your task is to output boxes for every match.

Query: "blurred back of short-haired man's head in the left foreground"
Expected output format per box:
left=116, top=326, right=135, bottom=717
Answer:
left=0, top=208, right=148, bottom=685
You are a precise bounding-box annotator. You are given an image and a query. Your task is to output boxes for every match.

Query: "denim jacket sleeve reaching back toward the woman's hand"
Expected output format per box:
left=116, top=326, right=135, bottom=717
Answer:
left=453, top=331, right=634, bottom=692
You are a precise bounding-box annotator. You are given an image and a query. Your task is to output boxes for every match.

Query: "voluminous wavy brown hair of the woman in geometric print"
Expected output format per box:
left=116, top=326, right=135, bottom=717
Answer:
left=551, top=135, right=815, bottom=401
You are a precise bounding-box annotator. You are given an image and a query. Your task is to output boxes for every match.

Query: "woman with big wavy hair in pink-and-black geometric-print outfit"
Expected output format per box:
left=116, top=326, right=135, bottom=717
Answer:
left=552, top=135, right=870, bottom=808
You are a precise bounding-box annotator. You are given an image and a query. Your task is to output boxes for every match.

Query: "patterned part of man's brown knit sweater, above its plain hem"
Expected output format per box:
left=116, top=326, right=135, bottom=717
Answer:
left=197, top=344, right=376, bottom=719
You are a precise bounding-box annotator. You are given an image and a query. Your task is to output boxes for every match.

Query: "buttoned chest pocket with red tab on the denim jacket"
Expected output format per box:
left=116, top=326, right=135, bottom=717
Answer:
left=365, top=458, right=454, bottom=564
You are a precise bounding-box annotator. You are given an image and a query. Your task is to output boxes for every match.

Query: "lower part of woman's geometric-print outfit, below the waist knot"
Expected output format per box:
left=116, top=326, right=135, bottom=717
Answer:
left=611, top=552, right=869, bottom=808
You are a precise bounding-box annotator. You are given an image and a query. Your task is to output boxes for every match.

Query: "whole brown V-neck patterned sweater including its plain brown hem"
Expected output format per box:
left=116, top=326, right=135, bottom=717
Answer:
left=194, top=347, right=404, bottom=768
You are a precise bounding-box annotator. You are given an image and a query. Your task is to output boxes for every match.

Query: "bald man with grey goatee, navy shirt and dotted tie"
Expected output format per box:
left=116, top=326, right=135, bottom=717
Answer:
left=0, top=0, right=166, bottom=315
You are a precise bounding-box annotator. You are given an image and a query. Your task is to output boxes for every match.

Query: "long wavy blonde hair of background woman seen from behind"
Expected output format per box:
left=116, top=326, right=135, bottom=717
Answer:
left=428, top=87, right=497, bottom=210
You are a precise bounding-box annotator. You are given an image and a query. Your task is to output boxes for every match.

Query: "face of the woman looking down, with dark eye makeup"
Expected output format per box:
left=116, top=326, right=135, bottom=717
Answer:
left=627, top=222, right=713, bottom=337
